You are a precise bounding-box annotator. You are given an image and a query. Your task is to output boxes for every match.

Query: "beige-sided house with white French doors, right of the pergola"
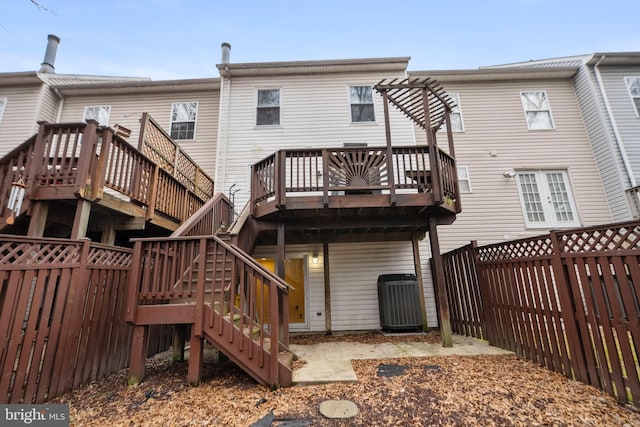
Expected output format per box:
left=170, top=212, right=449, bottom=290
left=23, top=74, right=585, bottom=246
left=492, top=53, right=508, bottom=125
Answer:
left=409, top=64, right=613, bottom=251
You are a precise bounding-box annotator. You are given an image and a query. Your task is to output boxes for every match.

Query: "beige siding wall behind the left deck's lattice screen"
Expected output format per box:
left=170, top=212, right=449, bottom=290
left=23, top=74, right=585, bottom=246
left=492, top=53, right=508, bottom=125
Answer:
left=61, top=90, right=220, bottom=177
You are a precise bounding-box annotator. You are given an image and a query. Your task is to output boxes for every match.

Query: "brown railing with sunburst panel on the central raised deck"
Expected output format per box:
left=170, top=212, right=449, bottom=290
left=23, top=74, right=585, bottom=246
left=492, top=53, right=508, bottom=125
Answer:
left=251, top=146, right=459, bottom=214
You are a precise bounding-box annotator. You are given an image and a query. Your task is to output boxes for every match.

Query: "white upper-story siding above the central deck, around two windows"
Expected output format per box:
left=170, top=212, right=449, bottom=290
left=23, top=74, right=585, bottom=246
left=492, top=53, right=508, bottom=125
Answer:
left=216, top=73, right=414, bottom=209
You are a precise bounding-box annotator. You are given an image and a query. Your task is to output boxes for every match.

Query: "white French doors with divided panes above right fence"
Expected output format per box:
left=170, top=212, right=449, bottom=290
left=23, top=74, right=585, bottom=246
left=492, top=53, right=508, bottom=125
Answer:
left=516, top=170, right=580, bottom=228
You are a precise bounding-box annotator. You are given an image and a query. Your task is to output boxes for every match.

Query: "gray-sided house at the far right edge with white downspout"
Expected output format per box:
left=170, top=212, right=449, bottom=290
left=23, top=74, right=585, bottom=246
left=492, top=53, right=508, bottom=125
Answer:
left=490, top=52, right=640, bottom=221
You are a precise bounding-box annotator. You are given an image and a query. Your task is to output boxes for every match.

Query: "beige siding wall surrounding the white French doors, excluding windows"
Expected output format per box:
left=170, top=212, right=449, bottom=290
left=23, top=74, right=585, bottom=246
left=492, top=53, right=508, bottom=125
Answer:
left=416, top=76, right=612, bottom=252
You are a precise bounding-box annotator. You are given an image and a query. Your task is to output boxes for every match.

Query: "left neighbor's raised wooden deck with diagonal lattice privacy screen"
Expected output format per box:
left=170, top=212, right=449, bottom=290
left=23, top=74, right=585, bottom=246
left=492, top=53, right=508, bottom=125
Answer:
left=0, top=114, right=213, bottom=243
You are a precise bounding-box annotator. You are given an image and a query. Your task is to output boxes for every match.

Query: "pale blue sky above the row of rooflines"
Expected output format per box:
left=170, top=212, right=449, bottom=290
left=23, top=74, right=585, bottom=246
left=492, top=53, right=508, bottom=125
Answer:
left=0, top=0, right=640, bottom=80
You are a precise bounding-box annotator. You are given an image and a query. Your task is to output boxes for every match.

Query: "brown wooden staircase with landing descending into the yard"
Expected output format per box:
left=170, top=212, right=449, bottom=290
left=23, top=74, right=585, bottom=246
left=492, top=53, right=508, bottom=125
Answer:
left=127, top=196, right=292, bottom=387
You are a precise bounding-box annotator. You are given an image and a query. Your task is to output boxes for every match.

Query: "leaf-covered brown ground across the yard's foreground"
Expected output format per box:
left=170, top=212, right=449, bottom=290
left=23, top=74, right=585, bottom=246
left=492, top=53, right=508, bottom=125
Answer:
left=52, top=334, right=640, bottom=427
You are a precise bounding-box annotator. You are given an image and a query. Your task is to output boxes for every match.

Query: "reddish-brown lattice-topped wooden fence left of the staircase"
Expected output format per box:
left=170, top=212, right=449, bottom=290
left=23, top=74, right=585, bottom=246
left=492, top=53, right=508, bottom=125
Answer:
left=0, top=235, right=172, bottom=404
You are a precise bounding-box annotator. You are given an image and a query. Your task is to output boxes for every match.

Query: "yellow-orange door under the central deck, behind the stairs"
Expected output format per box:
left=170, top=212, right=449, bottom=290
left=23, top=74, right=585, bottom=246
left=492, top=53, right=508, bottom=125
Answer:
left=258, top=257, right=308, bottom=330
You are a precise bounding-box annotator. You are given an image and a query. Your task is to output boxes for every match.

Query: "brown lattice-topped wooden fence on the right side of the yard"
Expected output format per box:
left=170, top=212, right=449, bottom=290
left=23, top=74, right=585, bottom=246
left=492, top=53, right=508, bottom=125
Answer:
left=444, top=221, right=640, bottom=408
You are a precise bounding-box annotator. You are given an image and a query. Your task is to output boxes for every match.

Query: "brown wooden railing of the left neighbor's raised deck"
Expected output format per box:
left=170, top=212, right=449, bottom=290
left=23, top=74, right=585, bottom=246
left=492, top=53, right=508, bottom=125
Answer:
left=0, top=120, right=213, bottom=222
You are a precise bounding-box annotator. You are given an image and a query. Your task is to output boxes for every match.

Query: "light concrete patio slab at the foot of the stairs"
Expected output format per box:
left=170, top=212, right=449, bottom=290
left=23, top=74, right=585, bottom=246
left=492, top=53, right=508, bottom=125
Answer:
left=289, top=335, right=513, bottom=385
